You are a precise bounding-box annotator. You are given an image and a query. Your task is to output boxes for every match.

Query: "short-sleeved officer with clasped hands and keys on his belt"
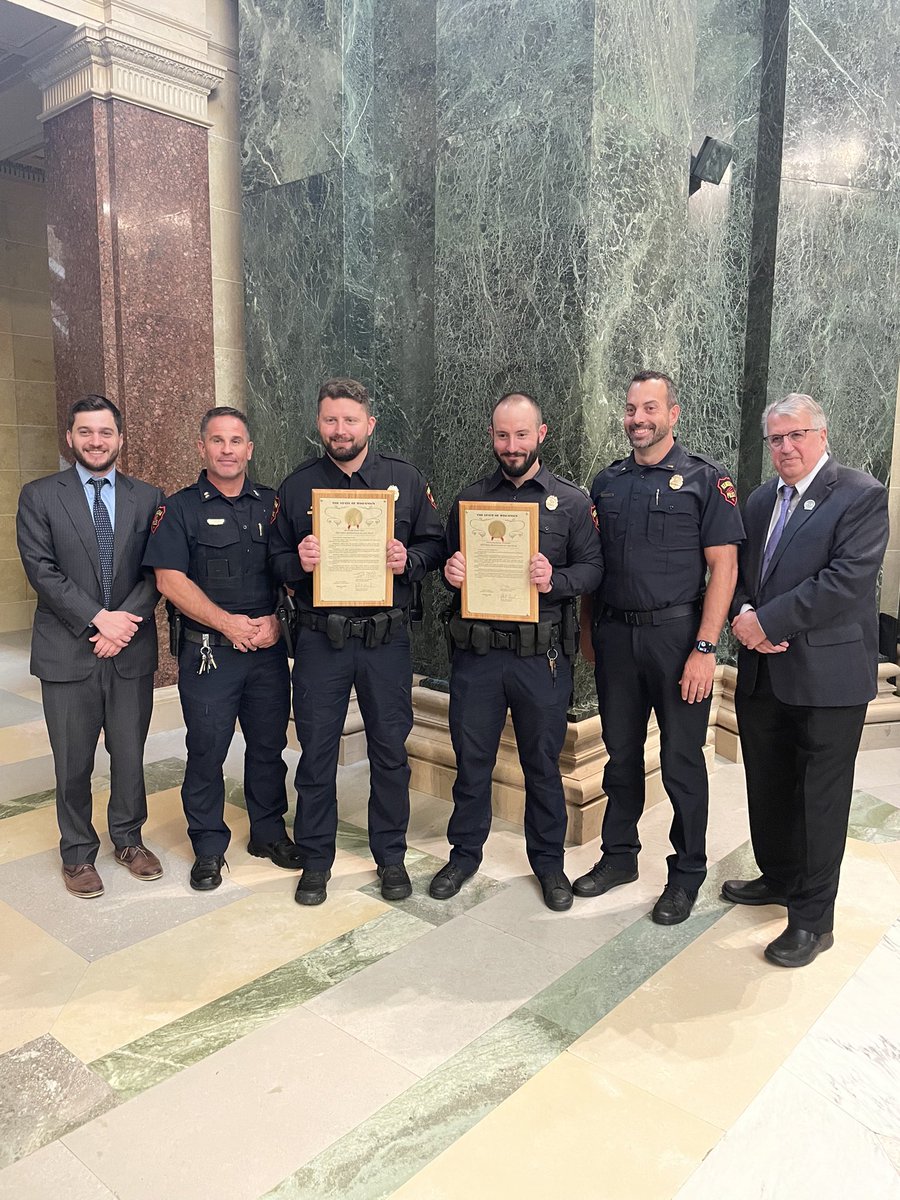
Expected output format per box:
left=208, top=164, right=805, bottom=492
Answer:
left=144, top=408, right=294, bottom=892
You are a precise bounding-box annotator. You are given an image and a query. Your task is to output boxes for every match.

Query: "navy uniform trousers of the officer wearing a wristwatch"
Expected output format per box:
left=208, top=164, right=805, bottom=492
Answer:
left=593, top=613, right=712, bottom=893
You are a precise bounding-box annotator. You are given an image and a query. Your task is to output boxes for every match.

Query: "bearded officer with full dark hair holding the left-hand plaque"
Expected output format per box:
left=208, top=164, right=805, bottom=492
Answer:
left=270, top=379, right=444, bottom=905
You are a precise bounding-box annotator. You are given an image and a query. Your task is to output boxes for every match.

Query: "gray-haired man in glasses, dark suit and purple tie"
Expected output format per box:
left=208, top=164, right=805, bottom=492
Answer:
left=722, top=394, right=888, bottom=967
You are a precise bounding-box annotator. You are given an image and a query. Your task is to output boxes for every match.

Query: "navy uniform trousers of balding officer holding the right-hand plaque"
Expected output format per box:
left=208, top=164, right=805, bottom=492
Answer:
left=446, top=648, right=572, bottom=875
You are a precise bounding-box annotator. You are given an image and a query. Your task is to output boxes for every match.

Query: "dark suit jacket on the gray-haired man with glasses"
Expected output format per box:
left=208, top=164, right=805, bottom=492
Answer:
left=732, top=457, right=888, bottom=708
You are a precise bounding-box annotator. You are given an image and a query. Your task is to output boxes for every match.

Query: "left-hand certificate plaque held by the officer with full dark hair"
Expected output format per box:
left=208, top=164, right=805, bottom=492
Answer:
left=312, top=487, right=394, bottom=608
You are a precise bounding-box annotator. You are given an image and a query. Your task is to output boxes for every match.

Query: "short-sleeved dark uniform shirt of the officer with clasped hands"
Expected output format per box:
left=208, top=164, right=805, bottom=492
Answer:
left=144, top=470, right=275, bottom=632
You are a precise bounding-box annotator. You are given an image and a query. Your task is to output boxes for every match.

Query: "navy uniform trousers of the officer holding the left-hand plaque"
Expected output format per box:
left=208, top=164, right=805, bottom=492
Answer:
left=293, top=626, right=413, bottom=871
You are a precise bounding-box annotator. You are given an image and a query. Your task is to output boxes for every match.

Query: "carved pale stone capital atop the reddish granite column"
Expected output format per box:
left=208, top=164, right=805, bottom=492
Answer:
left=29, top=25, right=224, bottom=126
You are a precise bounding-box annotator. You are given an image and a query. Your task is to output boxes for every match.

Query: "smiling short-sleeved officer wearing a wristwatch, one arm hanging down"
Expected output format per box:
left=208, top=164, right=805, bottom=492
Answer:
left=575, top=371, right=744, bottom=925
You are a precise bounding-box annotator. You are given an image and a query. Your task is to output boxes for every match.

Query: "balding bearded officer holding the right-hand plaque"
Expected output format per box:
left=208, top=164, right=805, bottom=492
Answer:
left=430, top=392, right=602, bottom=912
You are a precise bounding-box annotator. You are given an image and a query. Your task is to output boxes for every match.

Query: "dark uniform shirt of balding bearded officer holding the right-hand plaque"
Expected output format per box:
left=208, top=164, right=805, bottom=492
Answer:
left=446, top=464, right=604, bottom=629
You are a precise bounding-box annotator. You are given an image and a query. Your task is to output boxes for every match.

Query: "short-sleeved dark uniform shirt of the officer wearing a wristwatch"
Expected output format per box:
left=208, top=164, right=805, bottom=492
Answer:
left=590, top=443, right=744, bottom=612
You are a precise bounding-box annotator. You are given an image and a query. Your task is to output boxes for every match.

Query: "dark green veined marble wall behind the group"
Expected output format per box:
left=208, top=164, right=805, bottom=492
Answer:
left=240, top=0, right=900, bottom=696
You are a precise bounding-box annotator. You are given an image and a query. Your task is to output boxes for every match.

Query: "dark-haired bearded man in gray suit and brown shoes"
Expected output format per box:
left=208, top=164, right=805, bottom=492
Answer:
left=16, top=396, right=163, bottom=899
